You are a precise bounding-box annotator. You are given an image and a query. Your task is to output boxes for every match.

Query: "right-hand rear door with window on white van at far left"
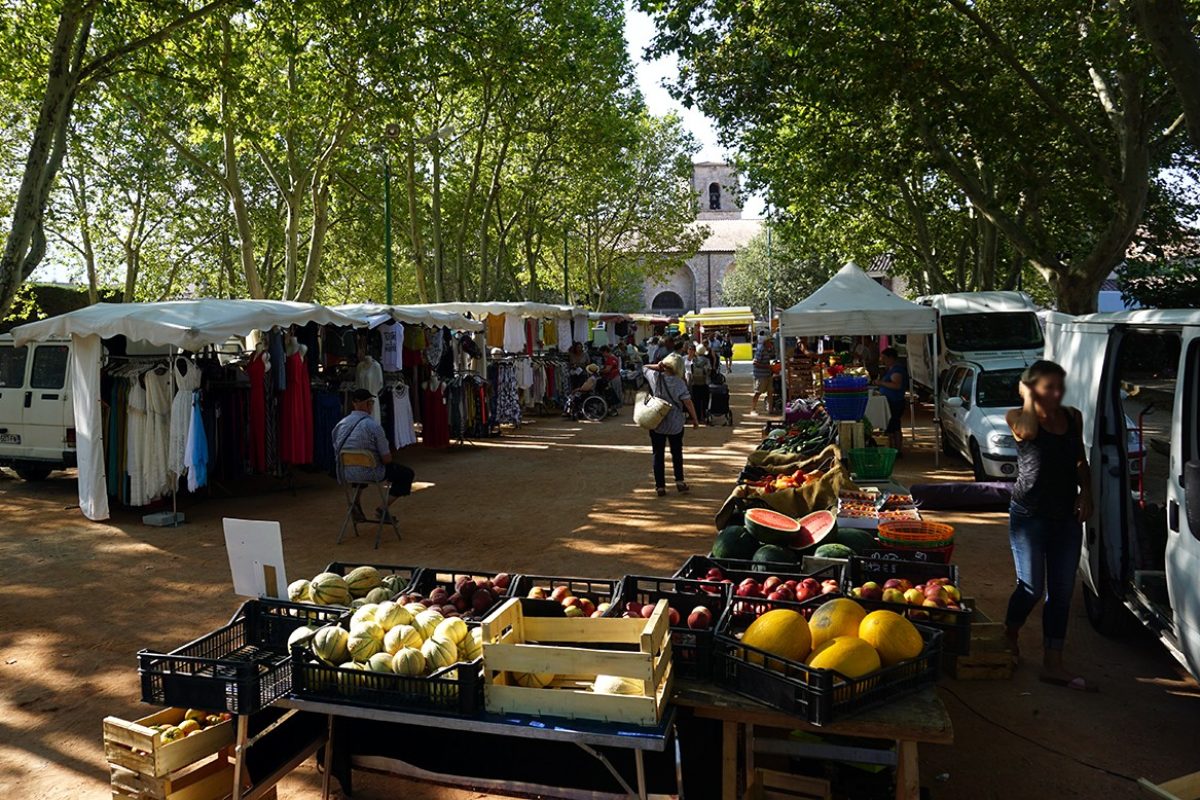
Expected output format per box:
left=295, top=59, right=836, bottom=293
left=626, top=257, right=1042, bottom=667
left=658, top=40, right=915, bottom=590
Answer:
left=22, top=342, right=71, bottom=462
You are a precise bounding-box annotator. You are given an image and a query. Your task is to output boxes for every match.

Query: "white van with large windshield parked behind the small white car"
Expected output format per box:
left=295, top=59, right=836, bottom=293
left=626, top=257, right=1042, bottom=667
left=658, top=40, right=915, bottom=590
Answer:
left=906, top=291, right=1044, bottom=390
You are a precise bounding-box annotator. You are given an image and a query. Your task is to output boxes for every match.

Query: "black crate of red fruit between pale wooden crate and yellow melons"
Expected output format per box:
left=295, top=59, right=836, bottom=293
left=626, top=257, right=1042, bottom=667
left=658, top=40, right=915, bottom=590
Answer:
left=605, top=575, right=730, bottom=679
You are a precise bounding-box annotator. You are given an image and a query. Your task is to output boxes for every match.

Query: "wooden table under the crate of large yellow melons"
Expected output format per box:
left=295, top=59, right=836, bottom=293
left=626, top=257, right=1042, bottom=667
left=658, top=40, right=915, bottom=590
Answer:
left=674, top=680, right=954, bottom=800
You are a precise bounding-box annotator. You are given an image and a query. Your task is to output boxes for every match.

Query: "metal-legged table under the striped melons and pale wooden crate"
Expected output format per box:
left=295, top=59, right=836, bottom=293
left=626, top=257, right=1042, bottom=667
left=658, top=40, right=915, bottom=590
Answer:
left=277, top=697, right=682, bottom=800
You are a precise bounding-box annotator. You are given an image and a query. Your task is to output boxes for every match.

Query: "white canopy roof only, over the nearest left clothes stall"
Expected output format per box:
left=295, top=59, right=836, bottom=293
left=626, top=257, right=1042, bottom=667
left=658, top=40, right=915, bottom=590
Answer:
left=12, top=299, right=362, bottom=350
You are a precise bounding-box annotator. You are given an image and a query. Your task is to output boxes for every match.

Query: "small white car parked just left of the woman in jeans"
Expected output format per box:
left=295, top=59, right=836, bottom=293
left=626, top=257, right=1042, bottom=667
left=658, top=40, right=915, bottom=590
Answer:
left=938, top=359, right=1142, bottom=481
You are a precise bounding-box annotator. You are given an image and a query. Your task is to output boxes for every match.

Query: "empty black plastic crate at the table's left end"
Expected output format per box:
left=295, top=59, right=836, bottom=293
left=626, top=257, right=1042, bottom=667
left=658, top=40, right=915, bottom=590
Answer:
left=138, top=599, right=346, bottom=714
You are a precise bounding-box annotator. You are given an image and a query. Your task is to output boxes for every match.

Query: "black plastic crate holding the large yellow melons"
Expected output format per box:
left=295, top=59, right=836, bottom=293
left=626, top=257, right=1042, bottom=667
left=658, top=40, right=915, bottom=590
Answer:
left=713, top=597, right=942, bottom=726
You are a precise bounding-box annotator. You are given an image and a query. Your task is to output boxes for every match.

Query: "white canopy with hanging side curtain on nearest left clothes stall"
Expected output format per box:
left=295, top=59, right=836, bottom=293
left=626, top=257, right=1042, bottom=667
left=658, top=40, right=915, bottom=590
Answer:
left=12, top=299, right=365, bottom=519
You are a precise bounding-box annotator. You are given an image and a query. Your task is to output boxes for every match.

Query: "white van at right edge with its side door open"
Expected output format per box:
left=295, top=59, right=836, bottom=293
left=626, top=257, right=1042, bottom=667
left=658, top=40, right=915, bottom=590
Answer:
left=1046, top=309, right=1200, bottom=676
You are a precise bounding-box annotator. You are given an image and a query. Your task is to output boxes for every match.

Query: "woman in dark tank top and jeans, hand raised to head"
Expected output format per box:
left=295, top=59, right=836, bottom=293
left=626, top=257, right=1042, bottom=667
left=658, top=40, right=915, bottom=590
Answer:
left=1004, top=361, right=1094, bottom=691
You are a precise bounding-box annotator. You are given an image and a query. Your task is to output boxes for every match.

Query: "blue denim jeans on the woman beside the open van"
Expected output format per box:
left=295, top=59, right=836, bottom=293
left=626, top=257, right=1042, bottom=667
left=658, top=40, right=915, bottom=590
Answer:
left=1004, top=503, right=1084, bottom=650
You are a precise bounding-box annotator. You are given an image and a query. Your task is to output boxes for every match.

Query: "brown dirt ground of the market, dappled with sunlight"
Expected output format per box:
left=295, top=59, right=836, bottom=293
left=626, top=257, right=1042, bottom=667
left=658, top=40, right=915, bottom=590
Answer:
left=0, top=375, right=1200, bottom=800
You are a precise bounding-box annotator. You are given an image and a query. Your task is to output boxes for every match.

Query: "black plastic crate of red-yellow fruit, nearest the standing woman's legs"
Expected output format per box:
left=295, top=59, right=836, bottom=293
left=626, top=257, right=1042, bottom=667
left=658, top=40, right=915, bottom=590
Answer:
left=842, top=557, right=974, bottom=656
